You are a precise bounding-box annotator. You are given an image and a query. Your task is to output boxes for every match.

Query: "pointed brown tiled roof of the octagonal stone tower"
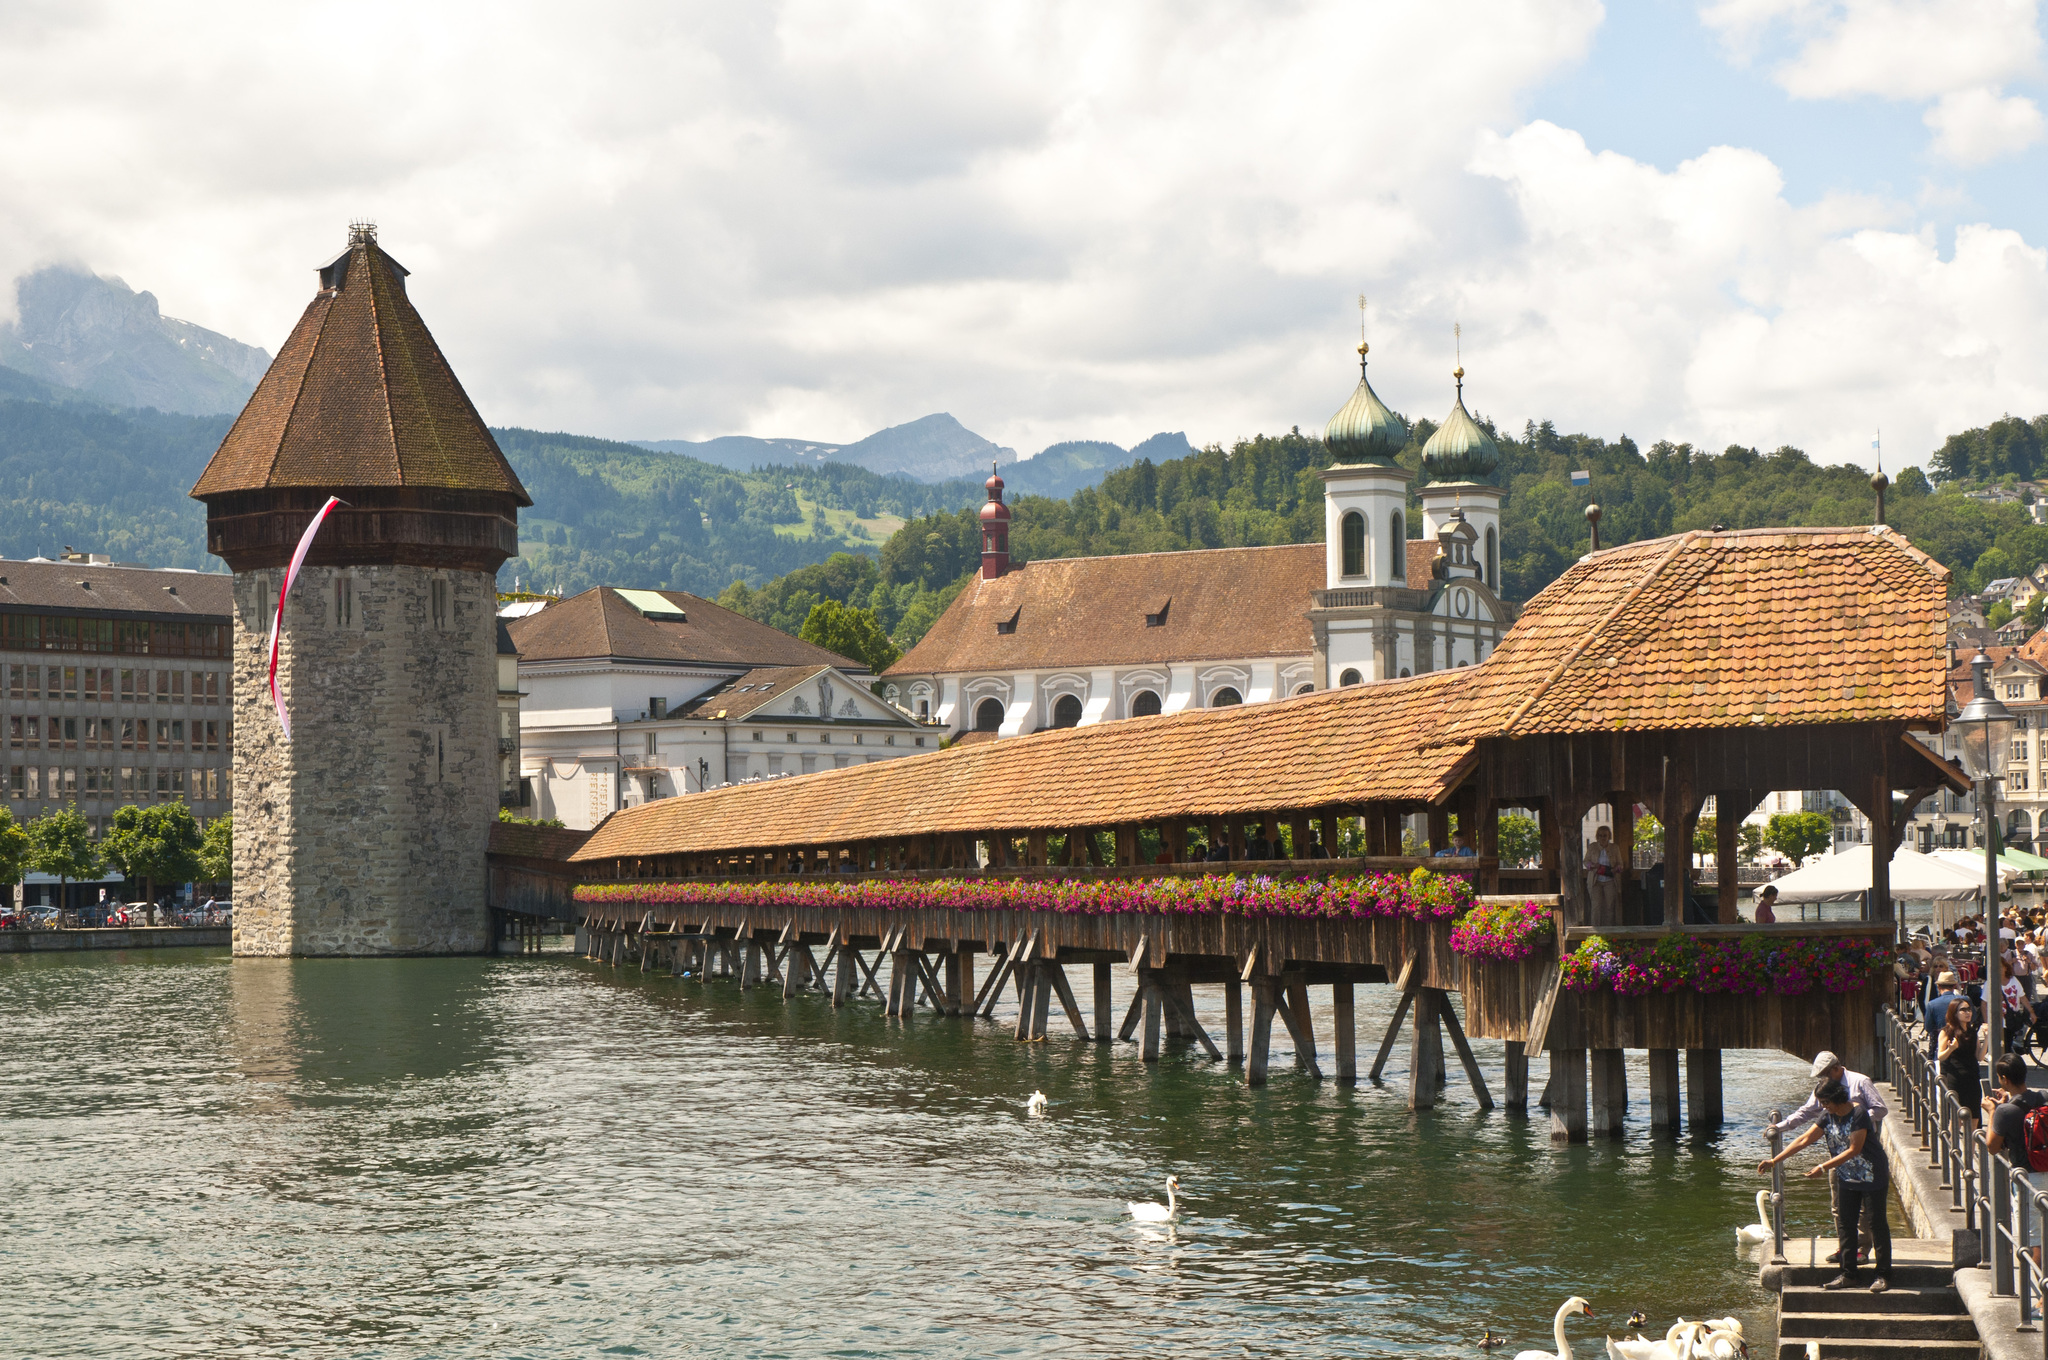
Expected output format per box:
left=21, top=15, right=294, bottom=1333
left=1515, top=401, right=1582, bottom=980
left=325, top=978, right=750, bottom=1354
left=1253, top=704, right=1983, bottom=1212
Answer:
left=193, top=233, right=532, bottom=506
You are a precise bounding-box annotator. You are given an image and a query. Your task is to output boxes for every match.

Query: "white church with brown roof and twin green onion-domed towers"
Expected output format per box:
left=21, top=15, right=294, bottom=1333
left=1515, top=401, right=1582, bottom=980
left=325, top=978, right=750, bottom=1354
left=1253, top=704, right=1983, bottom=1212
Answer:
left=883, top=346, right=1513, bottom=739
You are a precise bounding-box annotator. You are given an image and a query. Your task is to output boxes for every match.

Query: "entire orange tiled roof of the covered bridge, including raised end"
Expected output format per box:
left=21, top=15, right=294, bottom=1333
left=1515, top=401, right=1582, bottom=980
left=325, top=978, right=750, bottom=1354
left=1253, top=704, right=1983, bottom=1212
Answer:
left=578, top=528, right=1948, bottom=860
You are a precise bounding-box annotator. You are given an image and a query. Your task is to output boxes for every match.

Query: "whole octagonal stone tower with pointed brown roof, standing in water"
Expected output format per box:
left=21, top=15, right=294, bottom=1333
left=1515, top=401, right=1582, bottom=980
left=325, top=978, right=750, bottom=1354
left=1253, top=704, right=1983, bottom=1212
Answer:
left=193, top=225, right=532, bottom=954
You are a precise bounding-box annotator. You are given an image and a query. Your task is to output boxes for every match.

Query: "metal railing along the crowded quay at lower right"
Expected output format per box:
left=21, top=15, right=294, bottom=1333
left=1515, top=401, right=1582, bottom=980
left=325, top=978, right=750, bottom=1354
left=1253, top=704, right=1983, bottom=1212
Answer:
left=1878, top=1006, right=2048, bottom=1335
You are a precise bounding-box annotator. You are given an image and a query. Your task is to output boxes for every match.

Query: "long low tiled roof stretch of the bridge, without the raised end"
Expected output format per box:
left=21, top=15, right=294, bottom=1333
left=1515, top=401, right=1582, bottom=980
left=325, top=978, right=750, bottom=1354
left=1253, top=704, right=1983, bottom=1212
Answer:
left=575, top=670, right=1470, bottom=860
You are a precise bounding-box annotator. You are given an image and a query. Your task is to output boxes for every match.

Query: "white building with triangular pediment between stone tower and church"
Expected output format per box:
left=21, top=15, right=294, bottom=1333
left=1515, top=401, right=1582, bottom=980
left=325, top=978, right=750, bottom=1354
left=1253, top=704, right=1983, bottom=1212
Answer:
left=508, top=586, right=938, bottom=830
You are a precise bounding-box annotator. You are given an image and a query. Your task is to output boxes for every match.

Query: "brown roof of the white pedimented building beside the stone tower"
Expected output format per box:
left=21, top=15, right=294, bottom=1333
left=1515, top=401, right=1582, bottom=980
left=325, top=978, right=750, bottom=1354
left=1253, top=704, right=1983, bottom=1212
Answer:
left=506, top=586, right=868, bottom=676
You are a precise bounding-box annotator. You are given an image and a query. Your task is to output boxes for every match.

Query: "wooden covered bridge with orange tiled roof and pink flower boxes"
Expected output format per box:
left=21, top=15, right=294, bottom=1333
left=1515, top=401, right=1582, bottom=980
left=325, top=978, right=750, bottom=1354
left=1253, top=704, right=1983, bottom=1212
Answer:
left=492, top=526, right=1966, bottom=1139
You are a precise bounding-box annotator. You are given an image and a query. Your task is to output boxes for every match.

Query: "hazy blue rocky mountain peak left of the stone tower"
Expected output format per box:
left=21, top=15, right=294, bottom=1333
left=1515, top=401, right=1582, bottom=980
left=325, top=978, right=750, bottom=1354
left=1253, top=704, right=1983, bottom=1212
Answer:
left=0, top=264, right=270, bottom=416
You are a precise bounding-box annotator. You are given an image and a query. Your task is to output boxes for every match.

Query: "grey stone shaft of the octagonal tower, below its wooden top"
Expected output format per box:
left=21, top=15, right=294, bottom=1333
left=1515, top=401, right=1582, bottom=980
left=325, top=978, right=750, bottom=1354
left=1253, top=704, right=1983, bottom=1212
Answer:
left=233, top=565, right=498, bottom=957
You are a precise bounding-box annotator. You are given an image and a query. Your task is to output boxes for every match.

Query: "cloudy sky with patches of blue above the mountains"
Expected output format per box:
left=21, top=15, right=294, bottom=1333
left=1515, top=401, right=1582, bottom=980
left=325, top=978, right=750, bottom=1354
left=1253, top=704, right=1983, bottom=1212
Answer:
left=0, top=0, right=2048, bottom=469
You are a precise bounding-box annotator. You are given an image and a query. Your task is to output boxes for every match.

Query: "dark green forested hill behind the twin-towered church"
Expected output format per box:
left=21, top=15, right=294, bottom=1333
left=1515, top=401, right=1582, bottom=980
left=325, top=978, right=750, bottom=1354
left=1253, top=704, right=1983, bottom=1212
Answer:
left=723, top=409, right=2048, bottom=647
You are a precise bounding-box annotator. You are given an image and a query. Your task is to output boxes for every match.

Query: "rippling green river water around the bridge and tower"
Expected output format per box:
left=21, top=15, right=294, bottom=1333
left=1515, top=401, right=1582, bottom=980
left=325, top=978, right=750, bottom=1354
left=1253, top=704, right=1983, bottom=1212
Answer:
left=0, top=950, right=1892, bottom=1360
